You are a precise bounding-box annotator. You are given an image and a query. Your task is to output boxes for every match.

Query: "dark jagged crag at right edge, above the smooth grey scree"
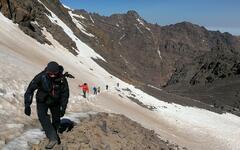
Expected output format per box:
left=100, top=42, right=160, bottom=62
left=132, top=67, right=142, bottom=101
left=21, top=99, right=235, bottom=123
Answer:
left=168, top=50, right=240, bottom=86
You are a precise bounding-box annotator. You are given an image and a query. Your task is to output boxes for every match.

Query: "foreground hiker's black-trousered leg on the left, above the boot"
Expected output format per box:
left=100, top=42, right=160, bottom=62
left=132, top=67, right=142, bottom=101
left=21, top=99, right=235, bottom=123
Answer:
left=37, top=103, right=57, bottom=141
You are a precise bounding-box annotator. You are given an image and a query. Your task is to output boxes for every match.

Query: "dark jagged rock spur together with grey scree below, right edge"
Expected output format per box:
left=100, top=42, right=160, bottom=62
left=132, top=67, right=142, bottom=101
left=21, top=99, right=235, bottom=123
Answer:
left=165, top=46, right=240, bottom=109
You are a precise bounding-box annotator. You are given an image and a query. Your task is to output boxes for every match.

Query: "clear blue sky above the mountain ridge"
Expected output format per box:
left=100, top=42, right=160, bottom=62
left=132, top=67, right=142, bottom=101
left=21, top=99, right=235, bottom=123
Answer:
left=61, top=0, right=240, bottom=35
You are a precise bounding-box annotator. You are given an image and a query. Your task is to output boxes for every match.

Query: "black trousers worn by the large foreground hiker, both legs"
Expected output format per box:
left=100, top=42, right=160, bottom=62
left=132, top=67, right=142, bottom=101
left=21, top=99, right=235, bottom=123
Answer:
left=37, top=103, right=60, bottom=140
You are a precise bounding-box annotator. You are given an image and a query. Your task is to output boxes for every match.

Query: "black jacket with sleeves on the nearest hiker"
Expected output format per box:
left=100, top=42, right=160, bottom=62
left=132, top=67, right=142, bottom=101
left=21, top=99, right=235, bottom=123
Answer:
left=24, top=71, right=69, bottom=111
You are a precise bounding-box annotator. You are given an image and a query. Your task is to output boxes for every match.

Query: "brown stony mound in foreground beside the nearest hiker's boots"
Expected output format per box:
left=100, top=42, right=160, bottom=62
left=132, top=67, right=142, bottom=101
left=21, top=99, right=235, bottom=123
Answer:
left=31, top=113, right=184, bottom=150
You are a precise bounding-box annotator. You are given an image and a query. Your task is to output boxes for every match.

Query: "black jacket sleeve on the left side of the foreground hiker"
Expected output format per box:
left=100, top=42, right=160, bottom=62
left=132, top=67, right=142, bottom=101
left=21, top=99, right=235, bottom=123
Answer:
left=24, top=74, right=41, bottom=106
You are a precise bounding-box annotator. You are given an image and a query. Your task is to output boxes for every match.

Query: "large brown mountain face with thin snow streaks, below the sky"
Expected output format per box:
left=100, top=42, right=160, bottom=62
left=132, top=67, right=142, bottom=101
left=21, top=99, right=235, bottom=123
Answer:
left=74, top=10, right=240, bottom=87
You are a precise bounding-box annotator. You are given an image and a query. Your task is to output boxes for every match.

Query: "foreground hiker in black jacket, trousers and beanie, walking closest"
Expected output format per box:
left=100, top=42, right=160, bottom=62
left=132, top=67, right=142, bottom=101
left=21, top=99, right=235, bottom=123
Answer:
left=24, top=61, right=69, bottom=149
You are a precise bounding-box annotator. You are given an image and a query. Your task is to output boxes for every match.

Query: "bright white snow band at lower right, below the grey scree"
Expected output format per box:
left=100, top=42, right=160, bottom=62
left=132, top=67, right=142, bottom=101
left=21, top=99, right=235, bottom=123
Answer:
left=109, top=82, right=240, bottom=150
